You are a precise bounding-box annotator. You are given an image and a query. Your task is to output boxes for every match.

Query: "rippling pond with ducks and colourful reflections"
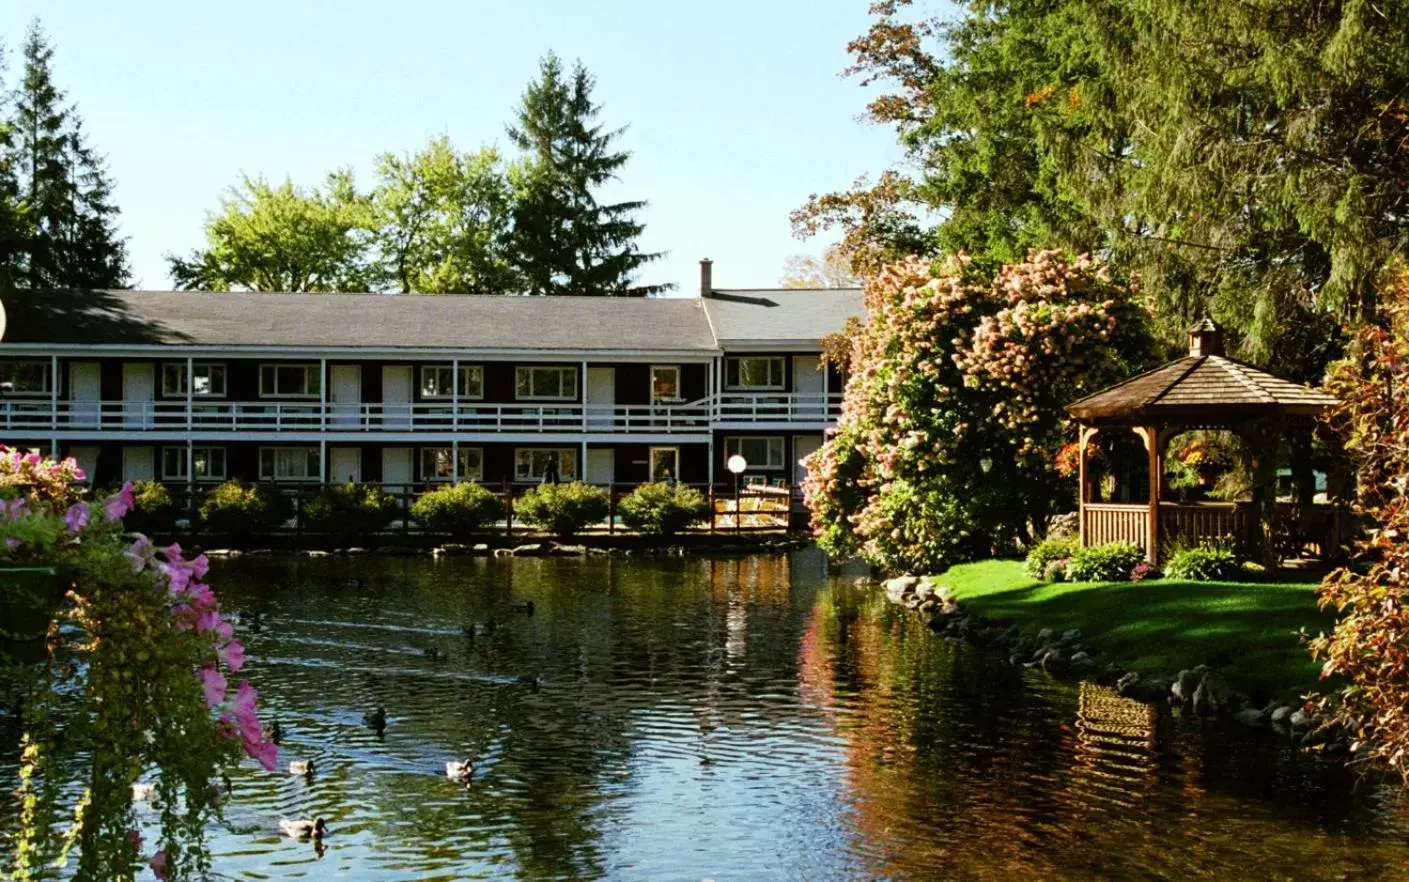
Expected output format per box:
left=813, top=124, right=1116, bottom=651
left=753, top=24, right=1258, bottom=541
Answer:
left=4, top=551, right=1409, bottom=882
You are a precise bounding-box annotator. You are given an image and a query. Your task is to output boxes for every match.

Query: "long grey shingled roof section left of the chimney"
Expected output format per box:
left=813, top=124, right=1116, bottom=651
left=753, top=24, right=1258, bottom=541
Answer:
left=4, top=290, right=716, bottom=352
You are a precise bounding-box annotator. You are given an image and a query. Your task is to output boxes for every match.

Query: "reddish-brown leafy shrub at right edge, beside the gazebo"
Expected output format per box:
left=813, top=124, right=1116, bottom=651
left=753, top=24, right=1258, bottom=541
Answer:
left=1312, top=273, right=1409, bottom=778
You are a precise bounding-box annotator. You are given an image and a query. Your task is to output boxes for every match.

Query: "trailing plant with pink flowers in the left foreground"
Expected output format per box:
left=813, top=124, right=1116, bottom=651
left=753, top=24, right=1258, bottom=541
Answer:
left=0, top=448, right=276, bottom=879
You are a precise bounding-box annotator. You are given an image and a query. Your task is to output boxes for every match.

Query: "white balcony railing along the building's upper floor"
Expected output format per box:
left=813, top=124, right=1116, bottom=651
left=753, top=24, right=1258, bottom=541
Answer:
left=0, top=393, right=841, bottom=434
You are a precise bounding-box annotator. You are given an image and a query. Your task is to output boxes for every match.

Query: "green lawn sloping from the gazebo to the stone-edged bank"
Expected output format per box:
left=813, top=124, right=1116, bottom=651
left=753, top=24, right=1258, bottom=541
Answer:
left=937, top=561, right=1333, bottom=697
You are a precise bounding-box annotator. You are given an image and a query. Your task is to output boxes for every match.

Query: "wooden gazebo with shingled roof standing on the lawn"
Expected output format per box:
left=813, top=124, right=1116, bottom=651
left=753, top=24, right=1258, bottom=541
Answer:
left=1067, top=318, right=1336, bottom=564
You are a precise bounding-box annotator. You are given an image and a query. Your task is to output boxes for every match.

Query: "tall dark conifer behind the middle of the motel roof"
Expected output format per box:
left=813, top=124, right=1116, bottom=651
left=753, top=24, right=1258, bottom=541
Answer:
left=509, top=54, right=669, bottom=297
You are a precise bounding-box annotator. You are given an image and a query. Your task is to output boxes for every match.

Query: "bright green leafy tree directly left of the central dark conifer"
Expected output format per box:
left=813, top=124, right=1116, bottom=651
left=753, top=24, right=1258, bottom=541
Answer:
left=372, top=135, right=521, bottom=294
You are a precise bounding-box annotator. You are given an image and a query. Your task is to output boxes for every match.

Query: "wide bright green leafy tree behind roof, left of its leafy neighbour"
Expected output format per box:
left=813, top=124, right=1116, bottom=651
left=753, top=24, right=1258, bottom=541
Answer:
left=166, top=172, right=371, bottom=292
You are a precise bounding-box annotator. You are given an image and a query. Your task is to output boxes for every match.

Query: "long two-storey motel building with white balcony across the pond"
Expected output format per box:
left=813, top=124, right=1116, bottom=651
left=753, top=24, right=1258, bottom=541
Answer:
left=0, top=261, right=861, bottom=489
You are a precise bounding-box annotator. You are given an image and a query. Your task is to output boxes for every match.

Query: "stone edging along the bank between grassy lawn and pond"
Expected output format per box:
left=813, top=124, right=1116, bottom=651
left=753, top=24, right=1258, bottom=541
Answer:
left=859, top=576, right=1346, bottom=754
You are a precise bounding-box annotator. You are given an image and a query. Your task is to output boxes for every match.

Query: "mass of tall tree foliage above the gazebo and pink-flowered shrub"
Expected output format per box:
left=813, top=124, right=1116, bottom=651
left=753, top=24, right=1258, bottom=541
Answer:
left=793, top=0, right=1409, bottom=371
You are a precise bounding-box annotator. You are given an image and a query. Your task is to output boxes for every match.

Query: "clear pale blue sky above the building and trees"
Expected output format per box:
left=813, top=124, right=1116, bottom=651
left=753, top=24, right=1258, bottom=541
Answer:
left=0, top=0, right=900, bottom=293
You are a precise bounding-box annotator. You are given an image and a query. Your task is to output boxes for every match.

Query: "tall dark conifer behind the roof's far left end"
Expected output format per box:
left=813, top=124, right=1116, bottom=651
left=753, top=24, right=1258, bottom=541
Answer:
left=0, top=23, right=127, bottom=289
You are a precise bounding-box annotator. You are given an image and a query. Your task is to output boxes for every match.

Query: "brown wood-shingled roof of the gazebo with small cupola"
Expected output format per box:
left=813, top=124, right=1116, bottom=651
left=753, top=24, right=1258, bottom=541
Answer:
left=1067, top=320, right=1336, bottom=424
